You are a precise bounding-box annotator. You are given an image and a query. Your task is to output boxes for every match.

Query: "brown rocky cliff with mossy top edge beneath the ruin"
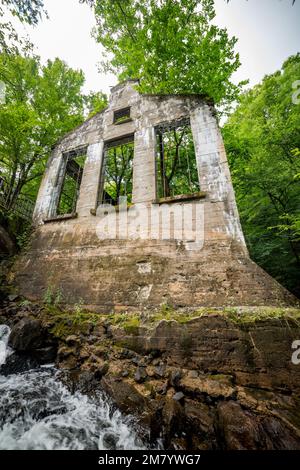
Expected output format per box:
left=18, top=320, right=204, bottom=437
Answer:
left=0, top=301, right=300, bottom=450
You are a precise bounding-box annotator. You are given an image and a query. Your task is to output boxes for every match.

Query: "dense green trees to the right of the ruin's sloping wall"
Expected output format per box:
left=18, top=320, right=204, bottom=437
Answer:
left=223, top=54, right=300, bottom=295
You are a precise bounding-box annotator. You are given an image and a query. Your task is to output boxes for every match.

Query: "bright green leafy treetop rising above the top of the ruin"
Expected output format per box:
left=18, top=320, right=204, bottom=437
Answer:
left=87, top=0, right=246, bottom=105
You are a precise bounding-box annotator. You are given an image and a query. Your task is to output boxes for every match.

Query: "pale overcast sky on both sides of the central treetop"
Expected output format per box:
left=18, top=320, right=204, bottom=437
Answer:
left=8, top=0, right=300, bottom=93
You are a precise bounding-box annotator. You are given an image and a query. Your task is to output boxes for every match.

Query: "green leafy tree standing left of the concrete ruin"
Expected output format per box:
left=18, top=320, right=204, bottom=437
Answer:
left=0, top=54, right=84, bottom=208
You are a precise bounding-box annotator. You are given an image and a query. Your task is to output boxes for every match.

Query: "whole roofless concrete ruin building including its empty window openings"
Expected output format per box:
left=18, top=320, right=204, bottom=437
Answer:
left=16, top=80, right=294, bottom=312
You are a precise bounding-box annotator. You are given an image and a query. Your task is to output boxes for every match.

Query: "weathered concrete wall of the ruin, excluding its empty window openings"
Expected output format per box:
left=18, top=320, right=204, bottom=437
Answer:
left=16, top=81, right=294, bottom=311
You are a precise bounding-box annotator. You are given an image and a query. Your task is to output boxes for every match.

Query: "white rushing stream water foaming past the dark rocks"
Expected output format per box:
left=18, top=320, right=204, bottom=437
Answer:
left=0, top=325, right=145, bottom=450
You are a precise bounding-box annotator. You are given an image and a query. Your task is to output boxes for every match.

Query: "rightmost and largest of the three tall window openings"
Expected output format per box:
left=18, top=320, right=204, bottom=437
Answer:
left=156, top=119, right=200, bottom=198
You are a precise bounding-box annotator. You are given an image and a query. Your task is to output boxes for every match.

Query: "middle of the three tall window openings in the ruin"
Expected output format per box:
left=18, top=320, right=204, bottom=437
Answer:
left=99, top=136, right=134, bottom=206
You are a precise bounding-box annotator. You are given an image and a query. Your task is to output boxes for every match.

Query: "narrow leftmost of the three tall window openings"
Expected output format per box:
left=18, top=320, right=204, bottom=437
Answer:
left=56, top=151, right=86, bottom=215
